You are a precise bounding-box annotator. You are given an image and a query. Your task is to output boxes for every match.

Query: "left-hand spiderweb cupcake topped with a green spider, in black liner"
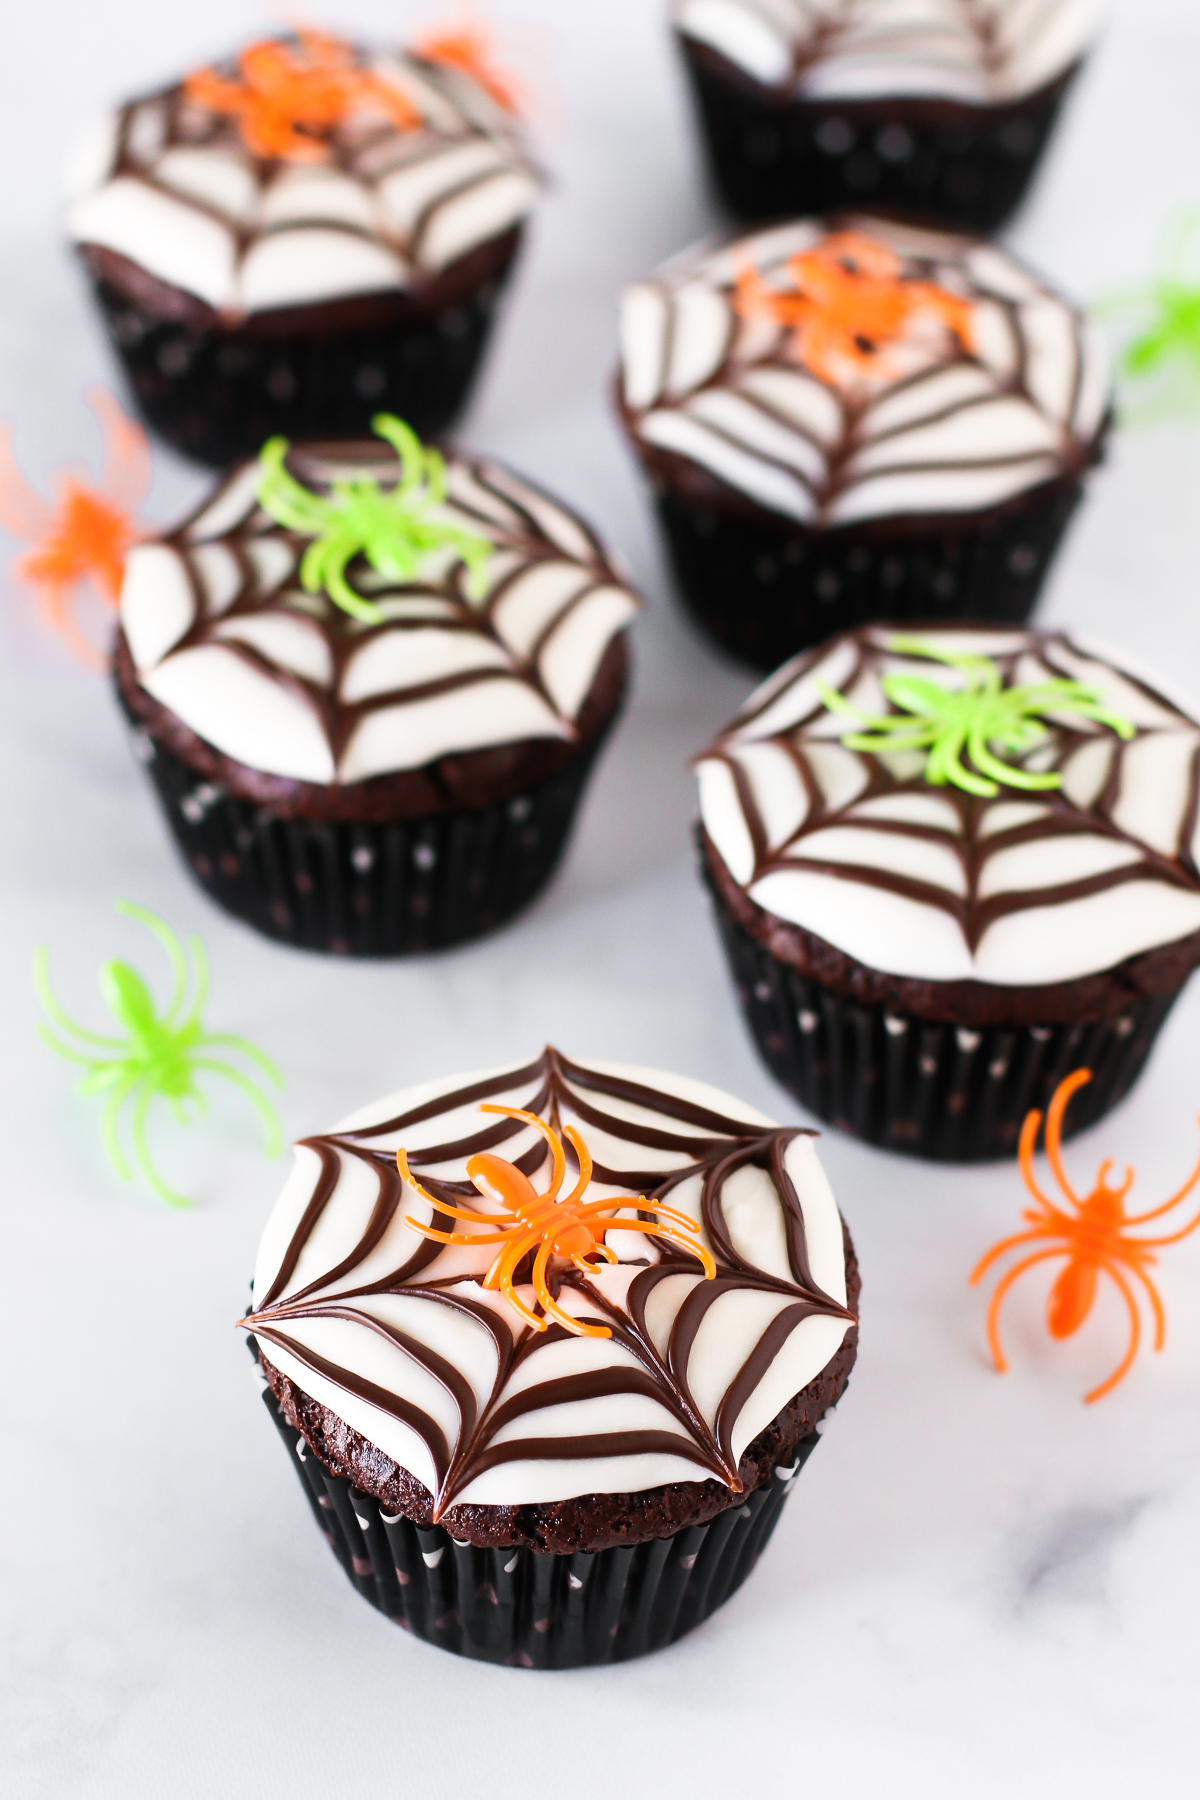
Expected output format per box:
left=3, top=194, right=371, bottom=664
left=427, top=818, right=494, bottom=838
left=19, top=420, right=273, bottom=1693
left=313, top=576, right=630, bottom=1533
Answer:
left=115, top=416, right=637, bottom=956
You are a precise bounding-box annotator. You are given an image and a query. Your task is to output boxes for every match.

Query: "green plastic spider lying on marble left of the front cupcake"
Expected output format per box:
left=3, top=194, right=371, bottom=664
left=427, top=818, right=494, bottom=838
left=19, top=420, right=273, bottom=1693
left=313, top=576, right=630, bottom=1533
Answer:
left=34, top=900, right=282, bottom=1206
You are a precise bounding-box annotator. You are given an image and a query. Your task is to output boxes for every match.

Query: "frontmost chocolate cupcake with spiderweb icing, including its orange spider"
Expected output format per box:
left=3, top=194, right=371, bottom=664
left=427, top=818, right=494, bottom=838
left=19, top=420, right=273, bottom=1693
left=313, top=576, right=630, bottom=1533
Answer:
left=245, top=1049, right=858, bottom=1669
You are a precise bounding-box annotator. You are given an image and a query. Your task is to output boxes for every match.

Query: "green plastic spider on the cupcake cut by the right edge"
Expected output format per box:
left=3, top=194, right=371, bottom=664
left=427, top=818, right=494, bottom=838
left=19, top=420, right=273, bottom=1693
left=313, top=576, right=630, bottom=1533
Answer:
left=819, top=637, right=1133, bottom=799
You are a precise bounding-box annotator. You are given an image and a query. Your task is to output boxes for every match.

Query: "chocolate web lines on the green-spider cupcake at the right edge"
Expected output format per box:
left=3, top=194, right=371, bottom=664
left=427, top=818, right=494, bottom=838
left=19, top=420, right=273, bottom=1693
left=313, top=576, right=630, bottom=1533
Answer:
left=698, top=626, right=1200, bottom=952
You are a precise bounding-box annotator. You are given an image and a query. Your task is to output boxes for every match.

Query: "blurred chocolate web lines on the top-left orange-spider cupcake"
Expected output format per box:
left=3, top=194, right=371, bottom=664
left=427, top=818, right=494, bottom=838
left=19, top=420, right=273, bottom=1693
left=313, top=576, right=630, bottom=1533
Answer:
left=96, top=49, right=538, bottom=320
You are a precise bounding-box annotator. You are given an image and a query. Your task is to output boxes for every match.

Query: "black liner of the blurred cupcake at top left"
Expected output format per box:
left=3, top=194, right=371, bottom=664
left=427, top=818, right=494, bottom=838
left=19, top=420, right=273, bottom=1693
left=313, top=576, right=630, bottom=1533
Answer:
left=92, top=246, right=521, bottom=468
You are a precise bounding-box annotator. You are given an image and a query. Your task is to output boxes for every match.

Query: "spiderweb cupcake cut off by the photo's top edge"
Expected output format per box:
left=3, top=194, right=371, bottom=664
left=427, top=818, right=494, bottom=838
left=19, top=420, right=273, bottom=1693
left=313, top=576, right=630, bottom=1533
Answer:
left=675, top=0, right=1096, bottom=232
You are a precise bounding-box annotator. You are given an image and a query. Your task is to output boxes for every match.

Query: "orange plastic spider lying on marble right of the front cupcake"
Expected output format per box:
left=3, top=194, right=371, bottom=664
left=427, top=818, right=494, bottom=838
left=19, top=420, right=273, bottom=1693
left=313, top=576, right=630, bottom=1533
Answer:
left=972, top=1069, right=1200, bottom=1404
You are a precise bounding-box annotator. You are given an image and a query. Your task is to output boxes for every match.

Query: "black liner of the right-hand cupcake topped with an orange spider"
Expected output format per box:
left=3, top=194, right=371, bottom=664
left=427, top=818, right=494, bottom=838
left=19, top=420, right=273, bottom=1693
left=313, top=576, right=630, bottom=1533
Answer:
left=657, top=475, right=1083, bottom=670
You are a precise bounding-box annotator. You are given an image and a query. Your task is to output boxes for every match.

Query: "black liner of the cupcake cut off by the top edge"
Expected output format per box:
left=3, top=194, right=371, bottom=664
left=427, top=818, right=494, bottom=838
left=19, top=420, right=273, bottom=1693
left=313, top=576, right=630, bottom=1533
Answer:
left=684, top=40, right=1079, bottom=236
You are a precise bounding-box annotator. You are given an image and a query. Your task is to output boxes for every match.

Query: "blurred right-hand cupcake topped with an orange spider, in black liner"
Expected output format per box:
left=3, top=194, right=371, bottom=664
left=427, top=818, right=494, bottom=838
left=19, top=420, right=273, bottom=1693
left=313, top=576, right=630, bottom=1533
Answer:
left=621, top=220, right=1110, bottom=668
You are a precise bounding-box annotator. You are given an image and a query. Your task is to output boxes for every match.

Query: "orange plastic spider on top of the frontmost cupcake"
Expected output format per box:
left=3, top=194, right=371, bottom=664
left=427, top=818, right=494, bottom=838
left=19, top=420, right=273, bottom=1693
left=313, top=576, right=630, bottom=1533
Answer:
left=396, top=1105, right=716, bottom=1337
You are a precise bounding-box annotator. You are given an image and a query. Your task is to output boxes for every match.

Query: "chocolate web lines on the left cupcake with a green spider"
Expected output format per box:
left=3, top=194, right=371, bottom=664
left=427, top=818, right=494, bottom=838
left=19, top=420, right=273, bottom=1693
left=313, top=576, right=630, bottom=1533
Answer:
left=137, top=439, right=628, bottom=769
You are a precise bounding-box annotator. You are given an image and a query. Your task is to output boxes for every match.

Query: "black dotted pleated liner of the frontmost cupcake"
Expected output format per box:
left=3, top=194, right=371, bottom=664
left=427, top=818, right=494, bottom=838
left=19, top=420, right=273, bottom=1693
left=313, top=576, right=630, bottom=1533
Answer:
left=263, top=1388, right=820, bottom=1669
